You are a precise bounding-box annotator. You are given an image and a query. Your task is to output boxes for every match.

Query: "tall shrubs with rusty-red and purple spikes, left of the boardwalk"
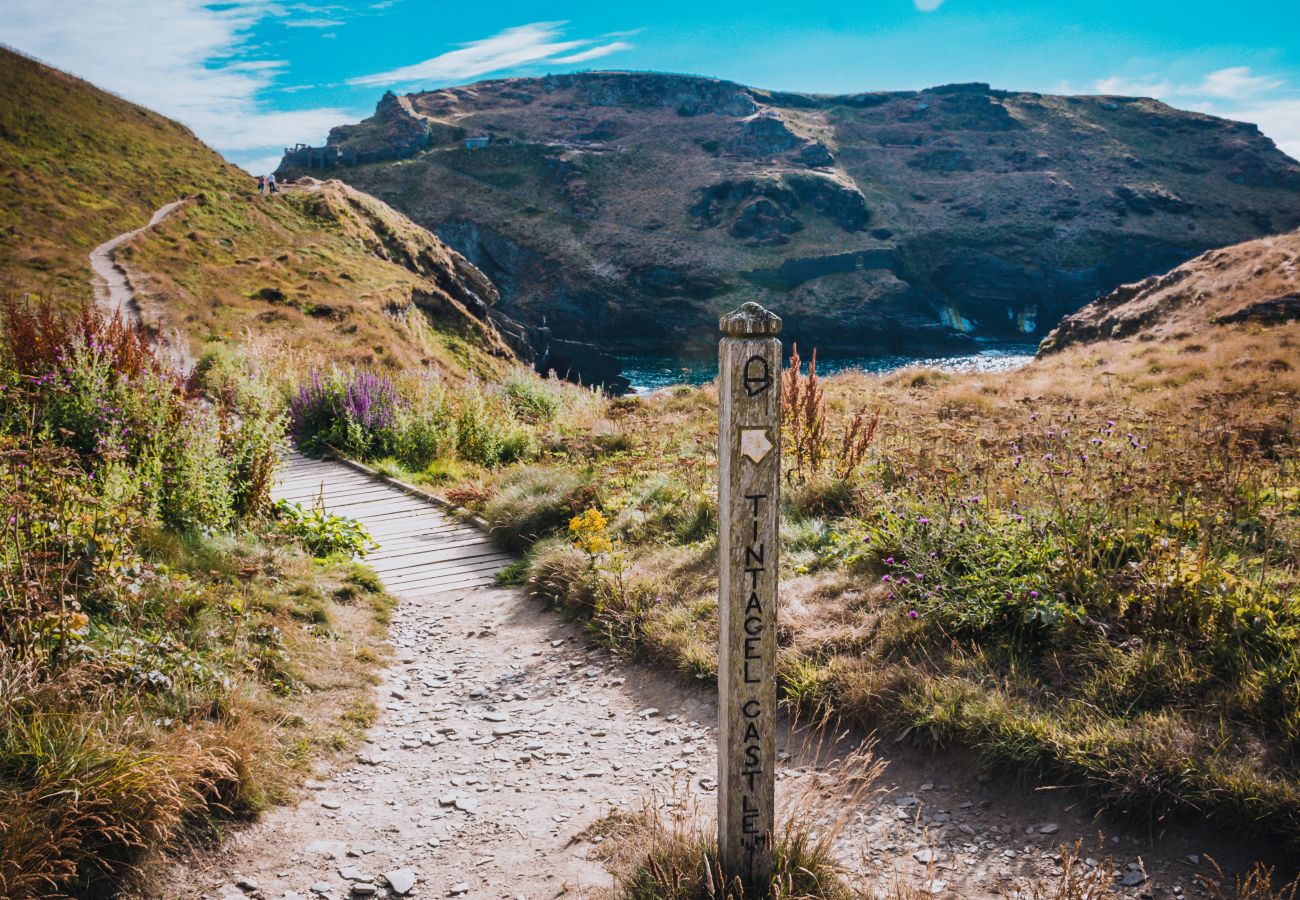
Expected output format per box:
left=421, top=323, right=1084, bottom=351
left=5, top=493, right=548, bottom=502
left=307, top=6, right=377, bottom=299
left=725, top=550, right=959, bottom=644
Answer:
left=0, top=301, right=282, bottom=531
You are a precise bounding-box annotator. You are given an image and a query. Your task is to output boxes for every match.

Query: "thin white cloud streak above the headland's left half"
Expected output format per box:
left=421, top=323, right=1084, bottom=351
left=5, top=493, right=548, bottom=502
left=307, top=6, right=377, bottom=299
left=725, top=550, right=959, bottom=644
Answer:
left=348, top=22, right=632, bottom=87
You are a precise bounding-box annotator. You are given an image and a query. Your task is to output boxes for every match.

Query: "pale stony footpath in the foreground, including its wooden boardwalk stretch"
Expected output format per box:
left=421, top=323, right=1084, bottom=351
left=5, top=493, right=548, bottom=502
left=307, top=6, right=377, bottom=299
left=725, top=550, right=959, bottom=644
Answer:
left=162, top=454, right=1242, bottom=900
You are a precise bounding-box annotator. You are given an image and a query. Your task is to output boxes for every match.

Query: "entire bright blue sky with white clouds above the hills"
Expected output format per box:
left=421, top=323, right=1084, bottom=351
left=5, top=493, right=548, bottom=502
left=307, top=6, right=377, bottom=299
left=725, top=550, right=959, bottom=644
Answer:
left=0, top=0, right=1300, bottom=172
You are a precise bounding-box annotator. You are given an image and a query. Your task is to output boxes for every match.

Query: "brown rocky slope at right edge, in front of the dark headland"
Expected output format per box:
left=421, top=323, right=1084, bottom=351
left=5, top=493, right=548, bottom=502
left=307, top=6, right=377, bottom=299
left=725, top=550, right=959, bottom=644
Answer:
left=1039, top=232, right=1300, bottom=356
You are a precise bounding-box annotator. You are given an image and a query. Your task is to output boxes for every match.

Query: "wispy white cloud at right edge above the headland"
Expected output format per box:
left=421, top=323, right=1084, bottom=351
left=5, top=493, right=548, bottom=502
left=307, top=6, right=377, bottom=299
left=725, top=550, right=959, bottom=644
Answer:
left=1093, top=65, right=1300, bottom=159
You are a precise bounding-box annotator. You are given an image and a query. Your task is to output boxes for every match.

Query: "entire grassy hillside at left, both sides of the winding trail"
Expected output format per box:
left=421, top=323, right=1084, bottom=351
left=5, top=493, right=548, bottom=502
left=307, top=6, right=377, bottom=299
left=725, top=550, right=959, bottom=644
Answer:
left=0, top=48, right=510, bottom=377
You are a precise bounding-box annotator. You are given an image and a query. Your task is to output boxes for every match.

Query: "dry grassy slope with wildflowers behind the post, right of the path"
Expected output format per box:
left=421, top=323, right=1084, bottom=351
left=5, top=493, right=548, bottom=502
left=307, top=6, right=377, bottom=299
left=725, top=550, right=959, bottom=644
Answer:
left=400, top=235, right=1300, bottom=856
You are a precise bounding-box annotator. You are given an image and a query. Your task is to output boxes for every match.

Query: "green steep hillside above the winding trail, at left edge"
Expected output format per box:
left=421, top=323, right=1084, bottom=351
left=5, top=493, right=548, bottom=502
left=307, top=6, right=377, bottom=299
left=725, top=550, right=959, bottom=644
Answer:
left=0, top=47, right=246, bottom=302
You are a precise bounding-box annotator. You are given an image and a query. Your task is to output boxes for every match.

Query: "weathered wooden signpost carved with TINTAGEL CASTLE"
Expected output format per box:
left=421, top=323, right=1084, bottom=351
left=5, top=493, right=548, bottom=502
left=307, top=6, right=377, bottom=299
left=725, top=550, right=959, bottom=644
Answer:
left=718, top=303, right=781, bottom=896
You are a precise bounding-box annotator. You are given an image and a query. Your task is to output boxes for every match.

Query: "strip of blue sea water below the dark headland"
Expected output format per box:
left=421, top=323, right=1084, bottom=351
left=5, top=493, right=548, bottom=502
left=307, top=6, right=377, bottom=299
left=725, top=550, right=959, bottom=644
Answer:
left=621, top=343, right=1037, bottom=394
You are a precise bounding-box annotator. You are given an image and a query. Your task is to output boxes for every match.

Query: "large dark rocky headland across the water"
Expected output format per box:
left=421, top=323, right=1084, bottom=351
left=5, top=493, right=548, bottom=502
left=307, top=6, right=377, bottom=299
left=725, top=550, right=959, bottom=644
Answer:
left=282, top=73, right=1300, bottom=352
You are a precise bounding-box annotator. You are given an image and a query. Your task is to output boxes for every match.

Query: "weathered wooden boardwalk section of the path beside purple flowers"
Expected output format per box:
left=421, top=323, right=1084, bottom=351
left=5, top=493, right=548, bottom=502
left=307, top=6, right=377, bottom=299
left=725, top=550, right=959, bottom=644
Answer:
left=272, top=453, right=514, bottom=597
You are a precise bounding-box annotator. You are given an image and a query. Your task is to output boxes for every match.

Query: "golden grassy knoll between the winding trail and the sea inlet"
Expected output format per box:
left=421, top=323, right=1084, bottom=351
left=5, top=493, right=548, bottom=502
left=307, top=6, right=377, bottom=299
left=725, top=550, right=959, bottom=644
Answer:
left=118, top=182, right=511, bottom=377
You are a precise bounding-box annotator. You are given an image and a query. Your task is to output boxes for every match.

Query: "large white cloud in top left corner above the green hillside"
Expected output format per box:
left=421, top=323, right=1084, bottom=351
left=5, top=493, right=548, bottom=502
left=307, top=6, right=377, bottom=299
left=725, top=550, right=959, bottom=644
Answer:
left=0, top=0, right=350, bottom=158
